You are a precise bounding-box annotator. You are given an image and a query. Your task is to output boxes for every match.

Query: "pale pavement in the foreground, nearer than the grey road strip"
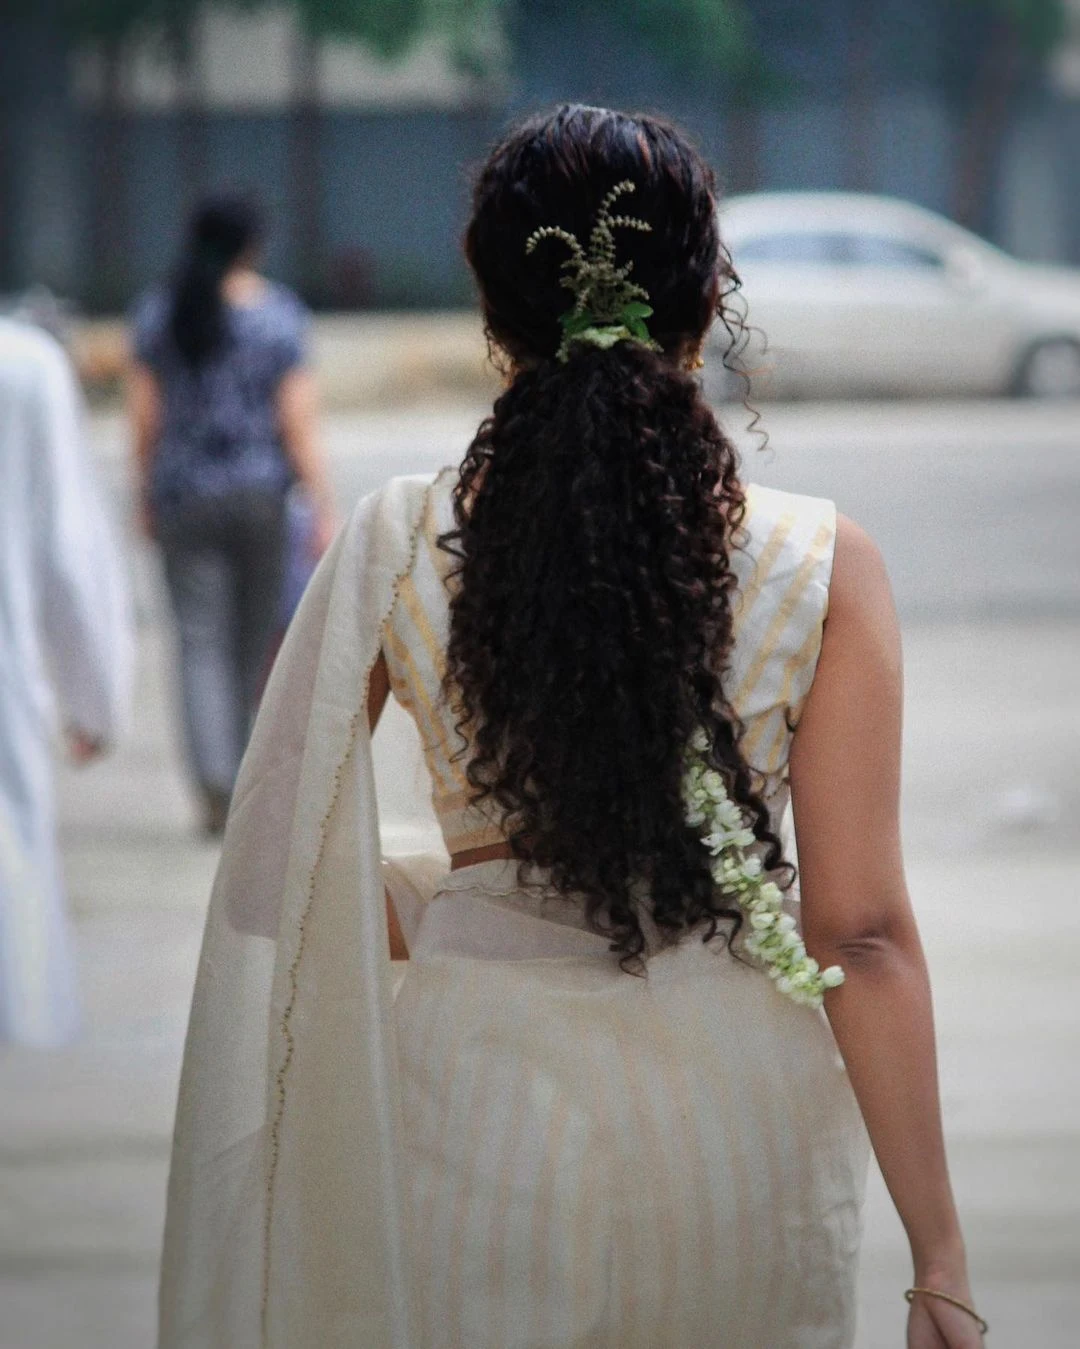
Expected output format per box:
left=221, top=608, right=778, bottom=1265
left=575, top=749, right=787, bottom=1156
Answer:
left=0, top=621, right=1080, bottom=1349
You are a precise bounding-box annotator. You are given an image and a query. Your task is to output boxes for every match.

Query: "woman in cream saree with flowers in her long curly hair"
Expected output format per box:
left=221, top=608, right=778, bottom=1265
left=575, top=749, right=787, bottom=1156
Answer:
left=160, top=107, right=982, bottom=1349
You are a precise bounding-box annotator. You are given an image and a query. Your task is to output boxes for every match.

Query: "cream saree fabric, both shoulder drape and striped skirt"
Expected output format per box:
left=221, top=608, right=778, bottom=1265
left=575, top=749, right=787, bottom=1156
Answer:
left=160, top=479, right=867, bottom=1349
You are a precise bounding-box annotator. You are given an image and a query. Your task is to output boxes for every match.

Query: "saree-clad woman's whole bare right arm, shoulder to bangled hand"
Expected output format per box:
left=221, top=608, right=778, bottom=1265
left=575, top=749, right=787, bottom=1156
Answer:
left=790, top=519, right=982, bottom=1349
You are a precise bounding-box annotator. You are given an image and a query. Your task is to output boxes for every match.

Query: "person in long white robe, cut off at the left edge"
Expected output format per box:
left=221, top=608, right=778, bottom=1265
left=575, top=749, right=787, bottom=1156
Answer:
left=0, top=318, right=133, bottom=1047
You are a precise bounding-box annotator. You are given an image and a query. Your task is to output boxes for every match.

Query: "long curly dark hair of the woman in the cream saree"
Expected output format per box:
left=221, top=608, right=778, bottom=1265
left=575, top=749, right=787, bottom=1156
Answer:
left=440, top=105, right=782, bottom=970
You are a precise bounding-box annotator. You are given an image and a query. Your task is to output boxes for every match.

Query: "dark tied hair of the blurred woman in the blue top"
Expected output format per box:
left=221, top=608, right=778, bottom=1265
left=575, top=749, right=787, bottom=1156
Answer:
left=170, top=196, right=262, bottom=368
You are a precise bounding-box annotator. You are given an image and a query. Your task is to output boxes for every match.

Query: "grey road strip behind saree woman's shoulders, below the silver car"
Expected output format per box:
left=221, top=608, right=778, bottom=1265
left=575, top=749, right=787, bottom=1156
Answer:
left=93, top=401, right=1080, bottom=619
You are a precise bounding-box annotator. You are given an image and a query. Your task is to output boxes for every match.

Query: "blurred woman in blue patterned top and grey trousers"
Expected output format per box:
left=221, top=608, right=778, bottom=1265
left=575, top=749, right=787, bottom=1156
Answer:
left=128, top=196, right=334, bottom=834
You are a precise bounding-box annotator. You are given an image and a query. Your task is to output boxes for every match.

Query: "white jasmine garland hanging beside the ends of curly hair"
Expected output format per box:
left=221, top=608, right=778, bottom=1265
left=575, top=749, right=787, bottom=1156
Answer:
left=682, top=727, right=844, bottom=1008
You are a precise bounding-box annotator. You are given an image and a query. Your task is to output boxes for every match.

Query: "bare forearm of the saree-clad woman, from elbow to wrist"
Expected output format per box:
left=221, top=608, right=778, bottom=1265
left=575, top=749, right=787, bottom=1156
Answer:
left=814, top=927, right=965, bottom=1278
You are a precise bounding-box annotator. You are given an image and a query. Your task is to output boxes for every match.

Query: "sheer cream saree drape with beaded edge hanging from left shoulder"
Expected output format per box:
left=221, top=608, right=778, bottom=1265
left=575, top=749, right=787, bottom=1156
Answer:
left=159, top=478, right=430, bottom=1349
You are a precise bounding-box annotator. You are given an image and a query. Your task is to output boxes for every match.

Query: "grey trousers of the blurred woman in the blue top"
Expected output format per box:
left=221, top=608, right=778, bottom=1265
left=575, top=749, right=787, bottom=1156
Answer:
left=158, top=492, right=286, bottom=797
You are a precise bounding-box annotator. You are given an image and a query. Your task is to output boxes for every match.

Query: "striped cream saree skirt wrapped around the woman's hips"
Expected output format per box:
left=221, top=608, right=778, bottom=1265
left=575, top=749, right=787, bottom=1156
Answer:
left=395, top=863, right=866, bottom=1349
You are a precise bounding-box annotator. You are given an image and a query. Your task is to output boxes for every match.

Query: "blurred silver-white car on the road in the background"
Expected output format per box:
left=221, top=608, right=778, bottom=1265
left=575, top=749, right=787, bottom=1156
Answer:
left=709, top=193, right=1080, bottom=398
